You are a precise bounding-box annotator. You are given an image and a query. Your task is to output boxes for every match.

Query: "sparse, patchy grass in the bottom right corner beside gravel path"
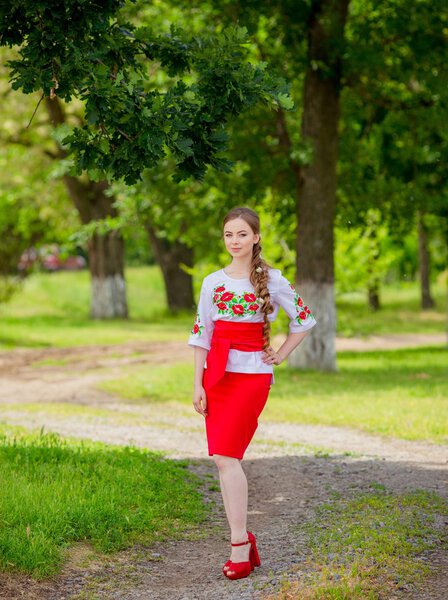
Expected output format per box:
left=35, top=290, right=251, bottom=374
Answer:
left=277, top=484, right=448, bottom=600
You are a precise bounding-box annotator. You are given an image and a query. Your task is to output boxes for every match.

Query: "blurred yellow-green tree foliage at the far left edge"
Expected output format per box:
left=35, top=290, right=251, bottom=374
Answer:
left=0, top=67, right=77, bottom=302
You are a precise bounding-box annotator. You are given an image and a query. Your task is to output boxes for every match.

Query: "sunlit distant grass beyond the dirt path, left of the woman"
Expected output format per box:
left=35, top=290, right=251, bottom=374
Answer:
left=0, top=267, right=193, bottom=349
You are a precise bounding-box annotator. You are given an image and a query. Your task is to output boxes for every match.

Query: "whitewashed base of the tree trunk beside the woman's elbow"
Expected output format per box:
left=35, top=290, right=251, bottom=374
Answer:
left=288, top=281, right=337, bottom=371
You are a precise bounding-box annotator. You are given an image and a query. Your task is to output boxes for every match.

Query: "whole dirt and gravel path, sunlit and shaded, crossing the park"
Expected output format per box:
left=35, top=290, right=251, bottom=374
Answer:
left=0, top=341, right=448, bottom=600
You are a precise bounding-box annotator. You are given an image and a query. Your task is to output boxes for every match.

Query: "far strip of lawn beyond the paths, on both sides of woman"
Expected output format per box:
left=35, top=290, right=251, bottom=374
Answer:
left=0, top=267, right=446, bottom=349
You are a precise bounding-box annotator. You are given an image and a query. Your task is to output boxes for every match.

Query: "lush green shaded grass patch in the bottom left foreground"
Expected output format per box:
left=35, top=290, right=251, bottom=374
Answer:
left=0, top=426, right=206, bottom=578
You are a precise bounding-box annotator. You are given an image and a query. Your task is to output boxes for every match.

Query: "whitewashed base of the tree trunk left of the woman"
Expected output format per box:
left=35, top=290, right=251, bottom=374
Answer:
left=90, top=274, right=128, bottom=319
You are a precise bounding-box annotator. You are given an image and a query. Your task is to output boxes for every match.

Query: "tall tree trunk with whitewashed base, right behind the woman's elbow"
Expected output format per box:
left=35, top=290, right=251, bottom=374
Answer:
left=289, top=0, right=349, bottom=371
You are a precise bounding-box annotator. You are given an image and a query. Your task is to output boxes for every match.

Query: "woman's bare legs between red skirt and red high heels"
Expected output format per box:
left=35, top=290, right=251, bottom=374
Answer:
left=213, top=454, right=250, bottom=574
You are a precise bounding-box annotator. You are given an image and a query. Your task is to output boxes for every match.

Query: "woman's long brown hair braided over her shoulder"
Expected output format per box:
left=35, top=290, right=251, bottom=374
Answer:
left=223, top=207, right=274, bottom=350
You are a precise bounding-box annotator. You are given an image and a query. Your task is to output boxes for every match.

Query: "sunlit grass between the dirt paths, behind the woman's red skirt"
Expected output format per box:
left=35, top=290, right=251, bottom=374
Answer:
left=100, top=348, right=448, bottom=443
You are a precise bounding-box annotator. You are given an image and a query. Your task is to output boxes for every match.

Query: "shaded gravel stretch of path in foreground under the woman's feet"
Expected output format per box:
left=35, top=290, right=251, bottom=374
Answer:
left=0, top=455, right=448, bottom=600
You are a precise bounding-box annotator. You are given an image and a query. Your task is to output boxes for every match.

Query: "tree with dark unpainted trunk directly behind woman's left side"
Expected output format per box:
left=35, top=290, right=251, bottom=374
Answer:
left=106, top=160, right=248, bottom=311
